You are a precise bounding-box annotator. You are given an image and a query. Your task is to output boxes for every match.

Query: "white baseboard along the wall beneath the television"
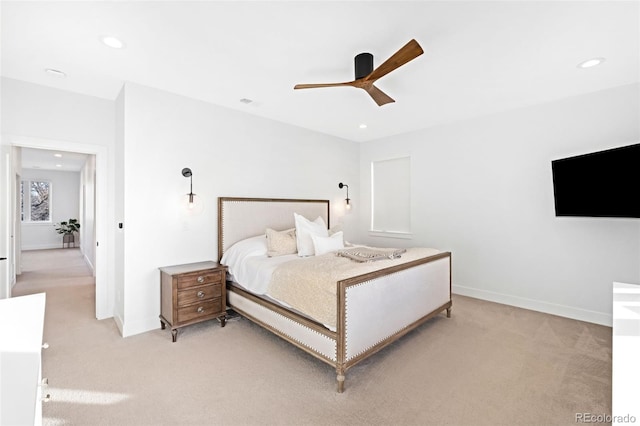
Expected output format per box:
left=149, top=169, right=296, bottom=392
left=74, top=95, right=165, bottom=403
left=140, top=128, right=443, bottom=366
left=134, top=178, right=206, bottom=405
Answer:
left=452, top=285, right=613, bottom=327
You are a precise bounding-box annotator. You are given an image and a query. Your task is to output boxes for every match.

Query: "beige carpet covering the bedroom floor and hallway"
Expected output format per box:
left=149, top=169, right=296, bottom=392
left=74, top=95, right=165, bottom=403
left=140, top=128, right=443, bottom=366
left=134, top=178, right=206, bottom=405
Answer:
left=14, top=249, right=611, bottom=425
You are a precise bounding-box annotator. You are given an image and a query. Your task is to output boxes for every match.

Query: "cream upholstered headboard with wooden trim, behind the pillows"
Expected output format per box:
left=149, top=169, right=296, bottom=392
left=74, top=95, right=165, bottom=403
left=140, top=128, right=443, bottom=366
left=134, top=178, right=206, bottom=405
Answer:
left=218, top=197, right=330, bottom=260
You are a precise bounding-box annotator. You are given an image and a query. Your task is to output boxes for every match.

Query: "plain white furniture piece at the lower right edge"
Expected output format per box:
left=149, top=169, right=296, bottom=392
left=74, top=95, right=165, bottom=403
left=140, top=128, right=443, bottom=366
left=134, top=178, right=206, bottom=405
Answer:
left=611, top=283, right=640, bottom=425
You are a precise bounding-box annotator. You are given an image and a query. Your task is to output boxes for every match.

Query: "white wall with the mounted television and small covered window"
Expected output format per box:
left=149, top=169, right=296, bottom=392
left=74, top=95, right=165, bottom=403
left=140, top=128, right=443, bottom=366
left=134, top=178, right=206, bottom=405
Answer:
left=360, top=85, right=640, bottom=325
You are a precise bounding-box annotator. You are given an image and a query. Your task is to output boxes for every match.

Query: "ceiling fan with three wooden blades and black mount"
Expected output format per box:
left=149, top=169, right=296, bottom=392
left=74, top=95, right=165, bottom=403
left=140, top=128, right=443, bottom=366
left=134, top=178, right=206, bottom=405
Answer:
left=294, top=39, right=424, bottom=106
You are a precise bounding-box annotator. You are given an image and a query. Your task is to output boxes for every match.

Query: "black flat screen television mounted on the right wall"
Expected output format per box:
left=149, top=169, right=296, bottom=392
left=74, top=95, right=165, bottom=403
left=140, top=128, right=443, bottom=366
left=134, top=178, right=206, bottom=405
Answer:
left=551, top=144, right=640, bottom=218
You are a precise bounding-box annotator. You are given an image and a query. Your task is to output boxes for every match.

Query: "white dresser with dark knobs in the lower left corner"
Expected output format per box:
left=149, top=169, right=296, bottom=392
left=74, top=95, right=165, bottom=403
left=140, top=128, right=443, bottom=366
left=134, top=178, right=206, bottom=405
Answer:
left=0, top=293, right=45, bottom=426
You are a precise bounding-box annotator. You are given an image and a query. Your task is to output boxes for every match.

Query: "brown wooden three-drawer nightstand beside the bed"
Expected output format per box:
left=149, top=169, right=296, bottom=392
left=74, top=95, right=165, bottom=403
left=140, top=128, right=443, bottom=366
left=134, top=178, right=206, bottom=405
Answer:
left=159, top=261, right=227, bottom=342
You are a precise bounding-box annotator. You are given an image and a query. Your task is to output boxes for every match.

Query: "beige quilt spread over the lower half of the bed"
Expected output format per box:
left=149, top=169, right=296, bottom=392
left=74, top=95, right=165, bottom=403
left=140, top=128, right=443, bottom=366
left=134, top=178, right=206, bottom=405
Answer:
left=267, top=247, right=440, bottom=330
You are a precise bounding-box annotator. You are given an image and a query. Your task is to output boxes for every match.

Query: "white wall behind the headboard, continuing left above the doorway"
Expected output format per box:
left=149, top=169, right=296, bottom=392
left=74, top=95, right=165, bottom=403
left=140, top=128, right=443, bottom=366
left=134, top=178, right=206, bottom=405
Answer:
left=1, top=78, right=358, bottom=336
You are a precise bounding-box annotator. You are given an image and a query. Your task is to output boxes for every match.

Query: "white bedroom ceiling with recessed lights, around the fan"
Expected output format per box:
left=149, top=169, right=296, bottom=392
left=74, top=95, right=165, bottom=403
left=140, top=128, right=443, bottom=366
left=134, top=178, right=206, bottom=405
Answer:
left=0, top=1, right=640, bottom=142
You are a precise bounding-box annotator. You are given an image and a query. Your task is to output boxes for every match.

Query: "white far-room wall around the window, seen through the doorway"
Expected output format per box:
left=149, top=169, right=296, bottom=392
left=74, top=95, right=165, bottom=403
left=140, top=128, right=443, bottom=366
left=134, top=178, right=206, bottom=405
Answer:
left=21, top=168, right=83, bottom=250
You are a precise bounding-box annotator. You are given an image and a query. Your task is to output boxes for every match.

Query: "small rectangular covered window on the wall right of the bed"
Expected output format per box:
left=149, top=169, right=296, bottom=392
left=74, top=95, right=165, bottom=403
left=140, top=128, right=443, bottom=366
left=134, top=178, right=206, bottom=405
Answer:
left=371, top=157, right=411, bottom=238
